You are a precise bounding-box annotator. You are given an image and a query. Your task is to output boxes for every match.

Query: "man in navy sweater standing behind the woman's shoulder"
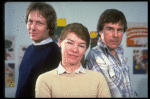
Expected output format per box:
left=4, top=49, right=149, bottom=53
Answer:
left=15, top=2, right=61, bottom=98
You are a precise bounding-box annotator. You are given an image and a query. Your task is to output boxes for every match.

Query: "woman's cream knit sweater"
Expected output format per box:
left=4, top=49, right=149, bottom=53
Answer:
left=35, top=68, right=110, bottom=98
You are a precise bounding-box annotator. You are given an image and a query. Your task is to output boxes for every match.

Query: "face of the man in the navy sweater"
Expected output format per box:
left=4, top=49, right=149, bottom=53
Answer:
left=27, top=11, right=50, bottom=43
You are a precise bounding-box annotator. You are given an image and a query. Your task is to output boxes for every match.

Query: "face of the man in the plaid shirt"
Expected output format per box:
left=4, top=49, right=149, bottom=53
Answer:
left=99, top=23, right=124, bottom=50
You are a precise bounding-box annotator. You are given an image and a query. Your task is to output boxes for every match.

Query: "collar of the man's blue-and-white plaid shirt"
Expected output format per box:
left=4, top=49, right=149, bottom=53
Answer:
left=97, top=38, right=124, bottom=55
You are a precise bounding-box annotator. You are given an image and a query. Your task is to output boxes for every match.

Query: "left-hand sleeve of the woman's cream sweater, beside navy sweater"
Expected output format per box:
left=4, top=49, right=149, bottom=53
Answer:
left=35, top=75, right=51, bottom=98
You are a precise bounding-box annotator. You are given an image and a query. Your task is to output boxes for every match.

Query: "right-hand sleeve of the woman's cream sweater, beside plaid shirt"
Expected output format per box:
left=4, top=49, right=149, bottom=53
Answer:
left=98, top=74, right=111, bottom=98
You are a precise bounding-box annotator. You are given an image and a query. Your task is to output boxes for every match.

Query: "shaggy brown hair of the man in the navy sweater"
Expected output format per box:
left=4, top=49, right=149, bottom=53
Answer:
left=25, top=2, right=57, bottom=39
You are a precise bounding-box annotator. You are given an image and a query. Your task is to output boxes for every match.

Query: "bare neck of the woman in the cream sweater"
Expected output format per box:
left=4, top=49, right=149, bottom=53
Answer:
left=62, top=62, right=80, bottom=73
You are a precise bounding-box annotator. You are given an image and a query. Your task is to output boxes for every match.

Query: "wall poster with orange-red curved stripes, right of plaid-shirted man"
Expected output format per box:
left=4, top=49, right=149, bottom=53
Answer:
left=126, top=22, right=148, bottom=47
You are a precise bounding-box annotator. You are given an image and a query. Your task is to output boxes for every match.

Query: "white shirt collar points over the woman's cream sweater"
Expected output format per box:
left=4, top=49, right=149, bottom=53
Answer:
left=58, top=62, right=86, bottom=74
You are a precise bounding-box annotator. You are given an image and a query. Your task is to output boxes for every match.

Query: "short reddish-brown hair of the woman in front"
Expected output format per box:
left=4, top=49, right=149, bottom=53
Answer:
left=59, top=23, right=90, bottom=49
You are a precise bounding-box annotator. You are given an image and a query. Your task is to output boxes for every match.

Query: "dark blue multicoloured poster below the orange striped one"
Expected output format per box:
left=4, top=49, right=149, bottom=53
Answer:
left=133, top=50, right=148, bottom=74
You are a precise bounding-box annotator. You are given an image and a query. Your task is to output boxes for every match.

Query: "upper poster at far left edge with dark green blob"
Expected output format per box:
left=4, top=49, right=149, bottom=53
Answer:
left=5, top=36, right=15, bottom=60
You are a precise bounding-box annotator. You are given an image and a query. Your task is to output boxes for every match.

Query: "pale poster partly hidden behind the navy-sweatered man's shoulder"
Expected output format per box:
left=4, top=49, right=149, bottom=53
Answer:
left=18, top=45, right=29, bottom=66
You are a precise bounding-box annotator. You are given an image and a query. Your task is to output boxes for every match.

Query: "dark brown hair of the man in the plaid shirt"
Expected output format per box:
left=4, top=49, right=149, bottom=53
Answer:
left=97, top=9, right=127, bottom=34
